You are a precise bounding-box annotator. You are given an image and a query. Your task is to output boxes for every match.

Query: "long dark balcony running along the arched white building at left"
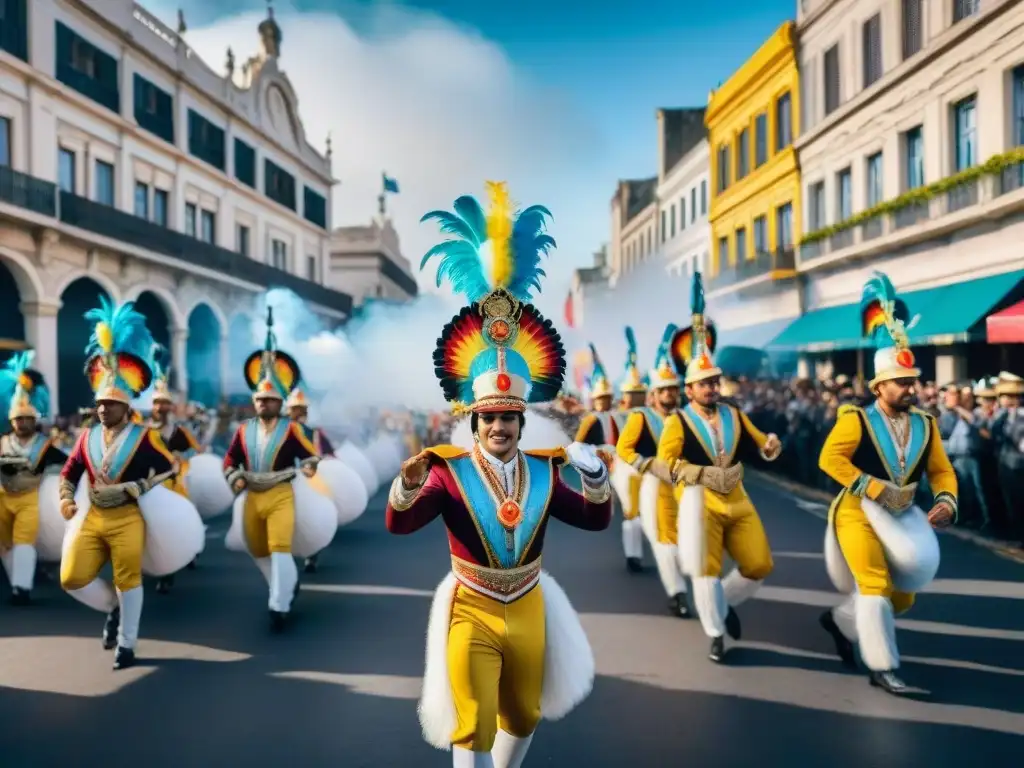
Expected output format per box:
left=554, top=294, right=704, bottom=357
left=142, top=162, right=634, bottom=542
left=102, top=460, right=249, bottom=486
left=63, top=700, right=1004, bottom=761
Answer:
left=0, top=167, right=352, bottom=315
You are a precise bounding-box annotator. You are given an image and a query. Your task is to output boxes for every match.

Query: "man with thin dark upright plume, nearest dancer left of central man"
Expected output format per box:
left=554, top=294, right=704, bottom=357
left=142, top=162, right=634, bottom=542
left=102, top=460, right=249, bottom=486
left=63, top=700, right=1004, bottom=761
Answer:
left=223, top=307, right=338, bottom=632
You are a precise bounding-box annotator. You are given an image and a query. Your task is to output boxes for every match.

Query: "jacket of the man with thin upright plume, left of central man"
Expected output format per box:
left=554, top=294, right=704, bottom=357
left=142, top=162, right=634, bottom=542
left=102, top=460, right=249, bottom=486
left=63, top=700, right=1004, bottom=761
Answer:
left=224, top=418, right=319, bottom=484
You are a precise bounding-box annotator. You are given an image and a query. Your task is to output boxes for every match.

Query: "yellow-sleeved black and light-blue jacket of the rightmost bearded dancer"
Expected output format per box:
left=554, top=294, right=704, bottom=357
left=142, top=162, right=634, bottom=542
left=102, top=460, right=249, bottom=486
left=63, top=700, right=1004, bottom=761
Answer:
left=818, top=402, right=957, bottom=514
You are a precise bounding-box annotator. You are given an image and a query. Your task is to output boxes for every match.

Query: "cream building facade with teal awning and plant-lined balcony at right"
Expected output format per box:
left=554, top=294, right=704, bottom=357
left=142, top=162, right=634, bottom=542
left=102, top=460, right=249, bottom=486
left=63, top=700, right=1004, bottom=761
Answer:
left=790, top=0, right=1024, bottom=382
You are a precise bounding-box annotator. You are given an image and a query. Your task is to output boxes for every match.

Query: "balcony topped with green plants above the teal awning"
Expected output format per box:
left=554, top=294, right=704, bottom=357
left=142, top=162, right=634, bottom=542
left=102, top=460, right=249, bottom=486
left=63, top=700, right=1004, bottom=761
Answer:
left=800, top=150, right=1024, bottom=269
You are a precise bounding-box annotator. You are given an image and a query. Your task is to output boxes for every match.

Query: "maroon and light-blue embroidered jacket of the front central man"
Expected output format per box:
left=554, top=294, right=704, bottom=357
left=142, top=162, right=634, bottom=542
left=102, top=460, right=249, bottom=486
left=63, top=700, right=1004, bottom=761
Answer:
left=385, top=445, right=611, bottom=591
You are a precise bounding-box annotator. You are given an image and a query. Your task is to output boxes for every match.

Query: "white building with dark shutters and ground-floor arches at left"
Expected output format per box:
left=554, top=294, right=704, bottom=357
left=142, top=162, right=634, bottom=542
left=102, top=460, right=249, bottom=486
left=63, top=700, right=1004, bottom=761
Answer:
left=0, top=0, right=351, bottom=414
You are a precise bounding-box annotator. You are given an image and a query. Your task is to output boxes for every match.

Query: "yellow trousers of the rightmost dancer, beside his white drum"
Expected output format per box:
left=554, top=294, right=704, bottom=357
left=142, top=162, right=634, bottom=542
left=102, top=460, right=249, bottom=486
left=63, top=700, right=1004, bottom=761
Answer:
left=833, top=494, right=914, bottom=613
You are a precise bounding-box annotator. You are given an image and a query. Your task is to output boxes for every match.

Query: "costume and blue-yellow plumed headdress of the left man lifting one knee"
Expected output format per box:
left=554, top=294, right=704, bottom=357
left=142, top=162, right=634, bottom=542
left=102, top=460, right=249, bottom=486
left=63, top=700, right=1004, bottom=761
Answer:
left=60, top=297, right=176, bottom=669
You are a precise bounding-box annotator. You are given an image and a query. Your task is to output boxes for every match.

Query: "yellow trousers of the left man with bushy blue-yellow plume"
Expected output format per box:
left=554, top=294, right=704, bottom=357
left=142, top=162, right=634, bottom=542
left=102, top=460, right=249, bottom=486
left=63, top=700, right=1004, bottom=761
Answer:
left=60, top=504, right=145, bottom=592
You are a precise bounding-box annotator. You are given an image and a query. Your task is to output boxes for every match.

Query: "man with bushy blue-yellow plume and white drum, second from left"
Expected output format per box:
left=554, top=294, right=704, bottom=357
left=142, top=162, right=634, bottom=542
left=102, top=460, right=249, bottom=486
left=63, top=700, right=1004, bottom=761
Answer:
left=60, top=297, right=202, bottom=669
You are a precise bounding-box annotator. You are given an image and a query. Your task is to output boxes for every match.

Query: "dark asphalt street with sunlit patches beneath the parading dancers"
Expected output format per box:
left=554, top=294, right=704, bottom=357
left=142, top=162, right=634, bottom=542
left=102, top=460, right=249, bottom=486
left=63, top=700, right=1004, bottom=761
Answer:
left=0, top=473, right=1024, bottom=768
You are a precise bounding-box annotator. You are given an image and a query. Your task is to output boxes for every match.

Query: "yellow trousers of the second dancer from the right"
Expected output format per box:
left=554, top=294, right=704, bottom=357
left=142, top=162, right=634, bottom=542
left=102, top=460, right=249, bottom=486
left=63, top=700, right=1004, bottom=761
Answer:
left=703, top=485, right=775, bottom=582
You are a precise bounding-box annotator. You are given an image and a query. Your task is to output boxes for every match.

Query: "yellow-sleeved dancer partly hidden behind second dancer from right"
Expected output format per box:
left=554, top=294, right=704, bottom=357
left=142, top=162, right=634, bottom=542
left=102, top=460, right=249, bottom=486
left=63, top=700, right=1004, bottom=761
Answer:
left=616, top=324, right=693, bottom=618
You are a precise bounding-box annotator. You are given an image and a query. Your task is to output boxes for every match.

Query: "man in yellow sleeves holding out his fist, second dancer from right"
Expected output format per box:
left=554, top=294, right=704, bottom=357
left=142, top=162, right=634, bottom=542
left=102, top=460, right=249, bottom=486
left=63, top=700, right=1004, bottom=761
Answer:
left=657, top=272, right=782, bottom=663
